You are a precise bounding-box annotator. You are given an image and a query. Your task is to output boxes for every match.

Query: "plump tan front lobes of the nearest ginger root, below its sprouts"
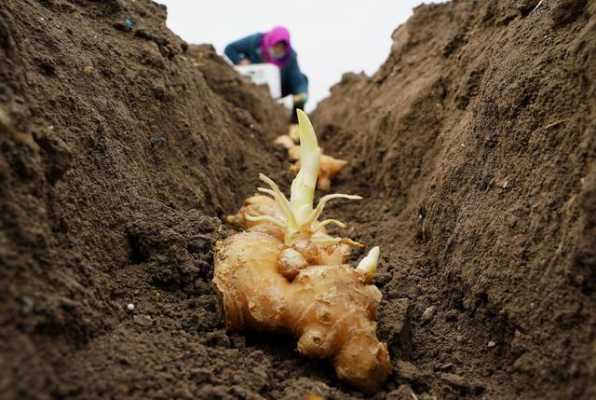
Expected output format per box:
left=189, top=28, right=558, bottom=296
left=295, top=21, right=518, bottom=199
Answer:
left=215, top=231, right=391, bottom=392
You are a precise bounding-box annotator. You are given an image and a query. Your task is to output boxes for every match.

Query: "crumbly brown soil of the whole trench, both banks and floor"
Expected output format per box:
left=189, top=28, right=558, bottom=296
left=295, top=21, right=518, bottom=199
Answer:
left=0, top=0, right=596, bottom=399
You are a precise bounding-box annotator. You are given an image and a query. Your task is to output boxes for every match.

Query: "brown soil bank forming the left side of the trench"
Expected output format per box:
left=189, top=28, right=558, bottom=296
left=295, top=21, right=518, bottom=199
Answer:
left=0, top=0, right=287, bottom=399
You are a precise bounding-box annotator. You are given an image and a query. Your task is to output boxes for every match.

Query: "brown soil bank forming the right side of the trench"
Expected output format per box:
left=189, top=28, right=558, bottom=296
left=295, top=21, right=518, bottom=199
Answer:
left=315, top=1, right=596, bottom=399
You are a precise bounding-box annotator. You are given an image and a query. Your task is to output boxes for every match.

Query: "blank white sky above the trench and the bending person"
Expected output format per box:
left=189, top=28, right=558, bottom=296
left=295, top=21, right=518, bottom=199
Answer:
left=151, top=0, right=436, bottom=110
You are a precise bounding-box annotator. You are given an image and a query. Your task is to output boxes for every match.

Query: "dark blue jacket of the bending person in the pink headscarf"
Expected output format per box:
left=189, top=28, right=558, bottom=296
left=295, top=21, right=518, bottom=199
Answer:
left=224, top=33, right=308, bottom=96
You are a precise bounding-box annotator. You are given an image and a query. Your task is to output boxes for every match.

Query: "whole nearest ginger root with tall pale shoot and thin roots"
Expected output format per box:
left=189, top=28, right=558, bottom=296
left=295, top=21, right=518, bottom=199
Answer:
left=213, top=112, right=391, bottom=392
